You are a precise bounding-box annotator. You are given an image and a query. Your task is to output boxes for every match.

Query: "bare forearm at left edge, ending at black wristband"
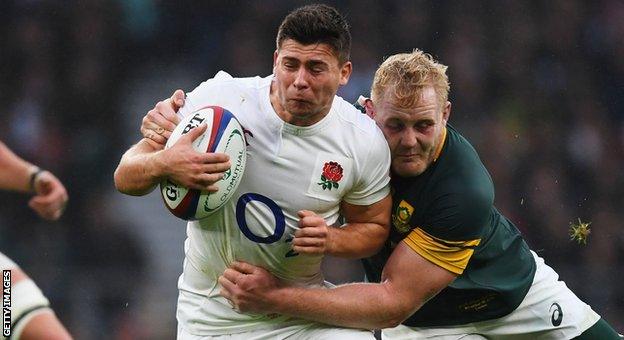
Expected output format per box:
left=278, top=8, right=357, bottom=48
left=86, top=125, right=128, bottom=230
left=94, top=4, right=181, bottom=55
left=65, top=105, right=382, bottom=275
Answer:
left=0, top=142, right=37, bottom=192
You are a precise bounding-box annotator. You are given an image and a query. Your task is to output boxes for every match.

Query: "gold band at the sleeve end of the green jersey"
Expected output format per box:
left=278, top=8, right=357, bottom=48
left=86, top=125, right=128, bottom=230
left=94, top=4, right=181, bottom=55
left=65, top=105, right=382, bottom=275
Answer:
left=403, top=228, right=481, bottom=275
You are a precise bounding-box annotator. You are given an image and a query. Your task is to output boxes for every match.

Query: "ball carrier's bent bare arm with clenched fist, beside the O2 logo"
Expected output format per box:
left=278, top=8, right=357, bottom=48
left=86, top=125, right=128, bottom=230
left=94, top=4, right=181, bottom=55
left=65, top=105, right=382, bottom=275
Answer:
left=292, top=195, right=392, bottom=258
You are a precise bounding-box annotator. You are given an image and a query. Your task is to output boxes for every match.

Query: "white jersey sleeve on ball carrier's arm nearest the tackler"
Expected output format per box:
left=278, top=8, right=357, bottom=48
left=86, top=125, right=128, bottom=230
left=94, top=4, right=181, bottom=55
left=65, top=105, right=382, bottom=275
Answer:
left=344, top=127, right=390, bottom=205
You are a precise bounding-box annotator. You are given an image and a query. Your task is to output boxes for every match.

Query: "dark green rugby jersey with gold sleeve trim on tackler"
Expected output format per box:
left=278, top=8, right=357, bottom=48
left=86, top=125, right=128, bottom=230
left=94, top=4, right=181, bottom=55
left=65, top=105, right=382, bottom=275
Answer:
left=364, top=125, right=535, bottom=327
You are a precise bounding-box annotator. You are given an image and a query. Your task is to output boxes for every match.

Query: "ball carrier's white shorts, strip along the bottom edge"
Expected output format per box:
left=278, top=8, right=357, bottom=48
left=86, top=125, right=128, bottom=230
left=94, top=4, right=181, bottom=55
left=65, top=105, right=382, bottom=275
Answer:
left=178, top=324, right=375, bottom=340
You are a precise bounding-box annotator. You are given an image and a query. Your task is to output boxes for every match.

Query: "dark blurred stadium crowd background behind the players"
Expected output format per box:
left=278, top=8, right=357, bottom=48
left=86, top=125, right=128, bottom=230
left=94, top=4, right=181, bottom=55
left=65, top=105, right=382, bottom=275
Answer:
left=0, top=0, right=624, bottom=339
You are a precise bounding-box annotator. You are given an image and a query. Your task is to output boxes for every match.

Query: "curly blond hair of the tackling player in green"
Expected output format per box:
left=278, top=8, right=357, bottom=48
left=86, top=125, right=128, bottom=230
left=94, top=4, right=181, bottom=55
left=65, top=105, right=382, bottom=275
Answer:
left=371, top=49, right=450, bottom=108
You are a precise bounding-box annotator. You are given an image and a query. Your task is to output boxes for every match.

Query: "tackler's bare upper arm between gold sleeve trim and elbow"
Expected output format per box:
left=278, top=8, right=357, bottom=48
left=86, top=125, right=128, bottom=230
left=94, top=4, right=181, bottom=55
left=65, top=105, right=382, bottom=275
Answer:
left=382, top=242, right=457, bottom=318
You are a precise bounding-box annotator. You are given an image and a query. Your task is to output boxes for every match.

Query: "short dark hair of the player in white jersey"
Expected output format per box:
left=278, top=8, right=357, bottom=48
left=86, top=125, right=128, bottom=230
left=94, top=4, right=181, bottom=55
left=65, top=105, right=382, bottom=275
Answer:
left=277, top=4, right=351, bottom=63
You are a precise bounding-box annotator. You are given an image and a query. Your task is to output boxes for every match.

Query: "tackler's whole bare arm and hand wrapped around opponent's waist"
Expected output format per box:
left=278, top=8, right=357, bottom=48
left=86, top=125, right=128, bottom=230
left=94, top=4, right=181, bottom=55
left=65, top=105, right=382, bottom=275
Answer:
left=219, top=242, right=456, bottom=329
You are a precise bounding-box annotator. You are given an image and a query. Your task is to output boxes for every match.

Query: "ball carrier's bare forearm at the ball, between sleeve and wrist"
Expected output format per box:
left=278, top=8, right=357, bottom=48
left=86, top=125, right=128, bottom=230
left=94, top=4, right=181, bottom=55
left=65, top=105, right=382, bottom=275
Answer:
left=115, top=140, right=165, bottom=196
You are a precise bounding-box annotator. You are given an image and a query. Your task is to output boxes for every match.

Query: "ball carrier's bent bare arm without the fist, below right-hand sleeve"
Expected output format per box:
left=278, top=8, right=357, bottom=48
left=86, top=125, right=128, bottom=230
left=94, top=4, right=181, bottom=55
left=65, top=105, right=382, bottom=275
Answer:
left=327, top=195, right=392, bottom=258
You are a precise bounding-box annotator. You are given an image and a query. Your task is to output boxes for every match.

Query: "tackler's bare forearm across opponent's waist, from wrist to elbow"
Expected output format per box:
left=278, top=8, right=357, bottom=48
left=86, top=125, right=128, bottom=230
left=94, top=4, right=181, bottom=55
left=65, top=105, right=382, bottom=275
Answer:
left=269, top=283, right=412, bottom=329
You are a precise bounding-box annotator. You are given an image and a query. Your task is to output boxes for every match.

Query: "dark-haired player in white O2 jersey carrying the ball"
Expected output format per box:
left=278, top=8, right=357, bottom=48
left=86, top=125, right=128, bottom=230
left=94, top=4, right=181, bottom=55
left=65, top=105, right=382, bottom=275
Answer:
left=115, top=5, right=391, bottom=339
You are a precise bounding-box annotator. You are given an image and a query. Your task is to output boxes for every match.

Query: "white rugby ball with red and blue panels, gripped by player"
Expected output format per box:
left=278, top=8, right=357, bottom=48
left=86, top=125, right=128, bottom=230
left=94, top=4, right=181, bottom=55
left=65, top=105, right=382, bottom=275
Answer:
left=160, top=106, right=247, bottom=220
